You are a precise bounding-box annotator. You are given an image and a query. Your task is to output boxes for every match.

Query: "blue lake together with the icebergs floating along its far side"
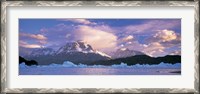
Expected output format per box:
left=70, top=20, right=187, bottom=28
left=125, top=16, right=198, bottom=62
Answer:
left=19, top=62, right=181, bottom=75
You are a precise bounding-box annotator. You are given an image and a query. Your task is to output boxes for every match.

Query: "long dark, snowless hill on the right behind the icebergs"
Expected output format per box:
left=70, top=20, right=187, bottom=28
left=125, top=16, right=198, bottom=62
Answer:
left=90, top=55, right=181, bottom=65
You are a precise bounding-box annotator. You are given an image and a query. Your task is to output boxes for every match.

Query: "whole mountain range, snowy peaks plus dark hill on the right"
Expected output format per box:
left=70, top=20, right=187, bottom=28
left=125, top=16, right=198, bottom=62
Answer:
left=20, top=41, right=181, bottom=65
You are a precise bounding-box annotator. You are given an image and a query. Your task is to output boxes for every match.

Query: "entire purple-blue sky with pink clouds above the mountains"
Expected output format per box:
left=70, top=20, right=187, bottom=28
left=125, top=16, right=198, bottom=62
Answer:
left=19, top=18, right=181, bottom=57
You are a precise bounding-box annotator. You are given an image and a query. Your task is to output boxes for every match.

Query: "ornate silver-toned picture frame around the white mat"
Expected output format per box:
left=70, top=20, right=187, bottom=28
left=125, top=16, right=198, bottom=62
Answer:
left=1, top=1, right=199, bottom=94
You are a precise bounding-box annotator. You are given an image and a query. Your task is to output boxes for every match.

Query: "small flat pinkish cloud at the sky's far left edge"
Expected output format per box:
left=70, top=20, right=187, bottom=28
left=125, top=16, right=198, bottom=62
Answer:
left=19, top=40, right=42, bottom=48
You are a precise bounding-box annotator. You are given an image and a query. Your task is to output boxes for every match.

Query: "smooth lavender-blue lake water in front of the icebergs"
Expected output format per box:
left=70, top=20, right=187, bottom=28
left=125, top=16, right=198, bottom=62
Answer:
left=19, top=67, right=181, bottom=75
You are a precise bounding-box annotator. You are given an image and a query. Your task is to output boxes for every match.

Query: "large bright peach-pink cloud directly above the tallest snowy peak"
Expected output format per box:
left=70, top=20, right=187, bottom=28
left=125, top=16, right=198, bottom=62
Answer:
left=74, top=25, right=117, bottom=49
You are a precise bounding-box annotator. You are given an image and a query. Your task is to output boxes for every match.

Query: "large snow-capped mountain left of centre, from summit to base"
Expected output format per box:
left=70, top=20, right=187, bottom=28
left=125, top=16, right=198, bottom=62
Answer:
left=25, top=41, right=111, bottom=64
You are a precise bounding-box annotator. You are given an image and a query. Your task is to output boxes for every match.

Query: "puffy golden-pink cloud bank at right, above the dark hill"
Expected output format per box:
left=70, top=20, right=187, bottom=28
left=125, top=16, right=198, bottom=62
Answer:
left=129, top=29, right=181, bottom=56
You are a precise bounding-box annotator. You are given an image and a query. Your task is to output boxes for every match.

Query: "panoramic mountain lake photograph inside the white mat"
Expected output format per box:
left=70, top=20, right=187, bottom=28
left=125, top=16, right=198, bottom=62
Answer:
left=18, top=18, right=181, bottom=75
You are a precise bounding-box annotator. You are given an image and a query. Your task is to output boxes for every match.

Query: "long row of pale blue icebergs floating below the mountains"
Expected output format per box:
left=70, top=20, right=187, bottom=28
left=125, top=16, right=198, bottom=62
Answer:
left=19, top=61, right=181, bottom=68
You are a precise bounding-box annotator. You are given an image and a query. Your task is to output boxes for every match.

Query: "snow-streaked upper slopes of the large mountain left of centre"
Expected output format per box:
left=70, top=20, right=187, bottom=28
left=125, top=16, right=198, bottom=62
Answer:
left=29, top=41, right=111, bottom=58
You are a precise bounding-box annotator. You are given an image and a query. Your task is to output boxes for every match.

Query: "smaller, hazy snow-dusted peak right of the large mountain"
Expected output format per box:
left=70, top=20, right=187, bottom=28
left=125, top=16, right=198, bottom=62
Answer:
left=110, top=48, right=145, bottom=59
